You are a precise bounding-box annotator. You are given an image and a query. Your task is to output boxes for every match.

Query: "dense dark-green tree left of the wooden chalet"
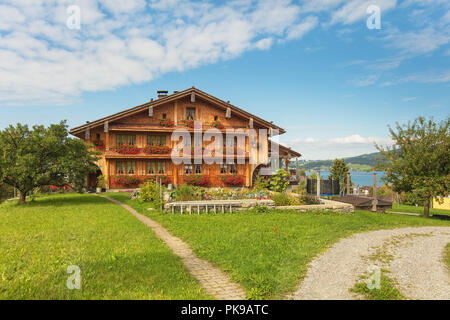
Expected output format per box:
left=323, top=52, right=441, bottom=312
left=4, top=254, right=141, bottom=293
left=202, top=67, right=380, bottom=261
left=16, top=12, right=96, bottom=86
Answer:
left=0, top=121, right=99, bottom=203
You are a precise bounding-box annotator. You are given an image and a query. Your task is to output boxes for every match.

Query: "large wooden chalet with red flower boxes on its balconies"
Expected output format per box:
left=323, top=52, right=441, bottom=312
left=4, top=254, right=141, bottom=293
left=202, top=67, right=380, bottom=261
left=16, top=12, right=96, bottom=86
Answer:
left=70, top=87, right=300, bottom=189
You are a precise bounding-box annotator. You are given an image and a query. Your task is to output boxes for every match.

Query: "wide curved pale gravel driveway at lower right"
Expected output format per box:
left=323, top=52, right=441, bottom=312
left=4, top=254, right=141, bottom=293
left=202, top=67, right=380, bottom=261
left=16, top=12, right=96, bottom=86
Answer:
left=288, top=227, right=450, bottom=300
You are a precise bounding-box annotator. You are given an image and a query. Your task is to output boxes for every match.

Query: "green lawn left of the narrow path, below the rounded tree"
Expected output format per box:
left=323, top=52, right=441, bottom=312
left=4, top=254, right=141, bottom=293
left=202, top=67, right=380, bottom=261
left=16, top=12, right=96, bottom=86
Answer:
left=0, top=194, right=209, bottom=300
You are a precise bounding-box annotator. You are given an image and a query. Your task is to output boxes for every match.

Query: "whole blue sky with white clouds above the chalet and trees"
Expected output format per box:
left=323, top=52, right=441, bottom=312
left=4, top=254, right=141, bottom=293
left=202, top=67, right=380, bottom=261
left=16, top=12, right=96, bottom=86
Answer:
left=0, top=0, right=450, bottom=159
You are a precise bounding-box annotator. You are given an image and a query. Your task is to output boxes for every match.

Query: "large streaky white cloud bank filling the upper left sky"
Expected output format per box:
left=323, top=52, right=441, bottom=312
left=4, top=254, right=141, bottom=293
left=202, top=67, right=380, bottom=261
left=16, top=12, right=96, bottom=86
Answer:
left=0, top=0, right=317, bottom=105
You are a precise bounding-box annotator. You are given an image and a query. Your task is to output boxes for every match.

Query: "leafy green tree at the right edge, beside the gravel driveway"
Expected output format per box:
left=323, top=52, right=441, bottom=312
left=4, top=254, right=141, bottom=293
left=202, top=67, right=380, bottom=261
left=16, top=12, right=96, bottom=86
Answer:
left=377, top=117, right=450, bottom=216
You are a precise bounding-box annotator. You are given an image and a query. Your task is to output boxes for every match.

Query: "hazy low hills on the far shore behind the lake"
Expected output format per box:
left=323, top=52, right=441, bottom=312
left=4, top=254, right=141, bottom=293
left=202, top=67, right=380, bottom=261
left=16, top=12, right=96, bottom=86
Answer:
left=294, top=152, right=381, bottom=171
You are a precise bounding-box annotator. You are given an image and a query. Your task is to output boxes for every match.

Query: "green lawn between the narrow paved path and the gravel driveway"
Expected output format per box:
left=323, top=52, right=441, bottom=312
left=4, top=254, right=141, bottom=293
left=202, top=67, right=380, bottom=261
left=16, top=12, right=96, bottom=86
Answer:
left=110, top=193, right=450, bottom=298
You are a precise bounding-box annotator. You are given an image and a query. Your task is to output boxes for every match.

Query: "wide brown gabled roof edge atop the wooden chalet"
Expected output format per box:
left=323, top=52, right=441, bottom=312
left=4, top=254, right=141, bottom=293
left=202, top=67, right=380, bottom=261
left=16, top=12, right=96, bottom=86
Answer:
left=70, top=87, right=286, bottom=135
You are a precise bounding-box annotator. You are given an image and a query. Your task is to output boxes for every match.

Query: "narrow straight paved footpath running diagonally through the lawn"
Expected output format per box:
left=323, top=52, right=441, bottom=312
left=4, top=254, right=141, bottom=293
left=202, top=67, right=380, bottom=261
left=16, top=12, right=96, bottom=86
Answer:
left=102, top=196, right=246, bottom=300
